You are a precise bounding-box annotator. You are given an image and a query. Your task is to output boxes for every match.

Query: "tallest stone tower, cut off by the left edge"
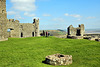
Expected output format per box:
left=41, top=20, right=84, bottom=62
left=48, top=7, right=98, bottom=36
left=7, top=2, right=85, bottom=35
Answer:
left=0, top=0, right=8, bottom=40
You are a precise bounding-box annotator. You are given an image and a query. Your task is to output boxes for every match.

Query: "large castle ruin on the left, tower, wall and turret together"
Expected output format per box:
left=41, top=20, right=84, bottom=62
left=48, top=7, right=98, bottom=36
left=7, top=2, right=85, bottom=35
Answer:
left=0, top=0, right=39, bottom=41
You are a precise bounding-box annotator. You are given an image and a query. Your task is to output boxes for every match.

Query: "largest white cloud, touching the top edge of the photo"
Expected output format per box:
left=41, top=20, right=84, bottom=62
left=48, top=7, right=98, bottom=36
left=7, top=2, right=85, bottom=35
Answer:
left=11, top=0, right=36, bottom=11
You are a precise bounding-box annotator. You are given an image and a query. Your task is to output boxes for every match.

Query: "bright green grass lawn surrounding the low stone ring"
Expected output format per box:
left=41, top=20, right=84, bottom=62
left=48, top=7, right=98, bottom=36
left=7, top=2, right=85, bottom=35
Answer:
left=0, top=37, right=100, bottom=67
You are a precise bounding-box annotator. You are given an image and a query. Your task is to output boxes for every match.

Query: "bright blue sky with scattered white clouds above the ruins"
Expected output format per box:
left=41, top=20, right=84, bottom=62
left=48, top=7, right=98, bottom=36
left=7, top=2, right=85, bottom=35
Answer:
left=6, top=0, right=100, bottom=30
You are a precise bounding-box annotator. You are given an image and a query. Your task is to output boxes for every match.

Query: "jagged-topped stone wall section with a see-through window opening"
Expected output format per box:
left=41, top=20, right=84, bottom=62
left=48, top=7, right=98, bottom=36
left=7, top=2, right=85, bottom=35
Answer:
left=7, top=19, right=20, bottom=38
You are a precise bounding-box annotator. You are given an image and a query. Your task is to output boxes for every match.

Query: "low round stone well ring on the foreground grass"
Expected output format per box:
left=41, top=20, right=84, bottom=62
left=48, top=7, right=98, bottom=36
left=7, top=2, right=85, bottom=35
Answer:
left=45, top=54, right=72, bottom=65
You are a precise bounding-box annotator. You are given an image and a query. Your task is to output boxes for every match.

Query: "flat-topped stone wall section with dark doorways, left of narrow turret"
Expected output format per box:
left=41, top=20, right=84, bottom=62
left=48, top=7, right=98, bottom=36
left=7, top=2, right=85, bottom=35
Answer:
left=19, top=23, right=35, bottom=37
